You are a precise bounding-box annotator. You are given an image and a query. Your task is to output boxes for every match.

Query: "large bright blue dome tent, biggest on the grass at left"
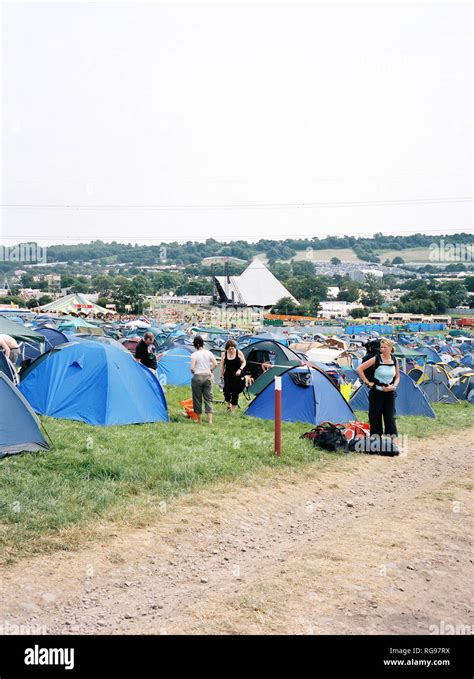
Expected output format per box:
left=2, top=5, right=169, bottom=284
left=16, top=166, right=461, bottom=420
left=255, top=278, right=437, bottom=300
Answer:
left=20, top=340, right=168, bottom=425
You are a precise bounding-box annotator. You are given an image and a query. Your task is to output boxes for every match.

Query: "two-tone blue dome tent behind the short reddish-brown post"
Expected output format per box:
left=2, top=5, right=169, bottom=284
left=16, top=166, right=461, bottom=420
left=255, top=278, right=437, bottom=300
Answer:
left=245, top=367, right=355, bottom=425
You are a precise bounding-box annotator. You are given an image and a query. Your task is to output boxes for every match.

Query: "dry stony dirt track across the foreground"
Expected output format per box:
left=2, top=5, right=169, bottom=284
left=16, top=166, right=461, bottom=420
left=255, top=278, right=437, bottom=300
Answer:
left=0, top=429, right=474, bottom=634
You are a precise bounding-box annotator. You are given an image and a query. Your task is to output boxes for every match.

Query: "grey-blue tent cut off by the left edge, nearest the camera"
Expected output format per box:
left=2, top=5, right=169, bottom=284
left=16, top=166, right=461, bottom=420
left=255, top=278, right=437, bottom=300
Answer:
left=0, top=373, right=49, bottom=457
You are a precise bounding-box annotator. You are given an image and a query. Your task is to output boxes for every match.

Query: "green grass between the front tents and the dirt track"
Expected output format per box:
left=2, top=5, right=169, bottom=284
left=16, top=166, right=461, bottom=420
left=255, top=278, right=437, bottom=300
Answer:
left=0, top=387, right=471, bottom=564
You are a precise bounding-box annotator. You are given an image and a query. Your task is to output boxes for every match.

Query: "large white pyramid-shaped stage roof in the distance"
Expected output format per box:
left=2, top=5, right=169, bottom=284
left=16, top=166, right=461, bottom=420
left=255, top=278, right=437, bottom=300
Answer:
left=216, top=259, right=298, bottom=306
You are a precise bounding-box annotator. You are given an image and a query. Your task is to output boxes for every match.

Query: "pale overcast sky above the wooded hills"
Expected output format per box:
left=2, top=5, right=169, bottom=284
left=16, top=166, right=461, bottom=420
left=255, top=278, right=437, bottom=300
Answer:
left=0, top=2, right=473, bottom=244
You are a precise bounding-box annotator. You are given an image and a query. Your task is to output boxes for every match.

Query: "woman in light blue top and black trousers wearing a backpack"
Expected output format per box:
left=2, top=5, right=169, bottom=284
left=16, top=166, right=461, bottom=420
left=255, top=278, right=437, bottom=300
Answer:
left=356, top=339, right=400, bottom=443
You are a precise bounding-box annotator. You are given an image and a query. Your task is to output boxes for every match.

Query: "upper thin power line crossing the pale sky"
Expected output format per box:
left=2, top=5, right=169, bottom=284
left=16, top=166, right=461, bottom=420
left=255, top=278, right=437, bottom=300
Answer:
left=0, top=196, right=474, bottom=210
